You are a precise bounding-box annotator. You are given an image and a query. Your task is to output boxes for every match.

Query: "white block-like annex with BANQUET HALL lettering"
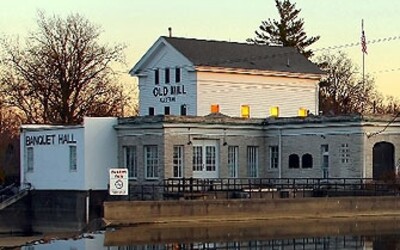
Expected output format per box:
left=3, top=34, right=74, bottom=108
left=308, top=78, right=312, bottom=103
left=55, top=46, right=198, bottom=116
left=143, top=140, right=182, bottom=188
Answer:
left=20, top=117, right=117, bottom=190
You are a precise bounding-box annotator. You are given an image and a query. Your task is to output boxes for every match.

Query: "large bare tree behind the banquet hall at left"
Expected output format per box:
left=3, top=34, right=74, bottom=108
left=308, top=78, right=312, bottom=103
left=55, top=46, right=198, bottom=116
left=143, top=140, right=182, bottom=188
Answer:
left=0, top=12, right=128, bottom=124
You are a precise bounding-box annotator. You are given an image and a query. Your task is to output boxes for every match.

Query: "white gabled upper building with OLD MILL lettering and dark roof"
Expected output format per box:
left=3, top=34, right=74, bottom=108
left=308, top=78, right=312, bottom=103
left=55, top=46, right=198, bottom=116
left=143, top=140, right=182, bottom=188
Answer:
left=130, top=37, right=322, bottom=118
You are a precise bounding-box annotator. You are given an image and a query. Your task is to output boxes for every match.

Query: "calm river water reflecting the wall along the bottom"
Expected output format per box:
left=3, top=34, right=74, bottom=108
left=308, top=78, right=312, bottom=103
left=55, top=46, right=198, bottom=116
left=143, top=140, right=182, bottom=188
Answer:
left=7, top=217, right=400, bottom=250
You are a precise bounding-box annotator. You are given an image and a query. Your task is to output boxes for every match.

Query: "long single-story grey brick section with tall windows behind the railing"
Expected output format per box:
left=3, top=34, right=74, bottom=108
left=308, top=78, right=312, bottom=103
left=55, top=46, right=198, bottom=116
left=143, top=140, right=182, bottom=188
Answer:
left=116, top=114, right=400, bottom=187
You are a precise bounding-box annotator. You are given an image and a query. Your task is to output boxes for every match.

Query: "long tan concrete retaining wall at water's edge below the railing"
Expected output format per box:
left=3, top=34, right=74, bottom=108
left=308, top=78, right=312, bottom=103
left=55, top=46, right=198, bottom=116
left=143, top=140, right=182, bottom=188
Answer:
left=104, top=197, right=400, bottom=225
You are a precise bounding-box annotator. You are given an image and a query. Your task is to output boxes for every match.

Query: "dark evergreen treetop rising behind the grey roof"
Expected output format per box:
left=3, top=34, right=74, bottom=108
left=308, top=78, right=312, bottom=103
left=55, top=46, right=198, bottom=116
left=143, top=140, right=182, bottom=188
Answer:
left=247, top=0, right=319, bottom=58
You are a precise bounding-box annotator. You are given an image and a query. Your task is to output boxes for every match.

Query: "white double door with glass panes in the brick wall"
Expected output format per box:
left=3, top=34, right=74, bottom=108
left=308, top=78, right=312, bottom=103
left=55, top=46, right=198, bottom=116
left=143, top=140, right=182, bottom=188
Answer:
left=193, top=140, right=219, bottom=179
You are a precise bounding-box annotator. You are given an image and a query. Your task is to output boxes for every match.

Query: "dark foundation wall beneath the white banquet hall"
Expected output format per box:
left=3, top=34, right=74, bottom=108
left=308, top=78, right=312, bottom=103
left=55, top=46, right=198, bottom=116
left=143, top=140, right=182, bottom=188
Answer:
left=0, top=190, right=107, bottom=233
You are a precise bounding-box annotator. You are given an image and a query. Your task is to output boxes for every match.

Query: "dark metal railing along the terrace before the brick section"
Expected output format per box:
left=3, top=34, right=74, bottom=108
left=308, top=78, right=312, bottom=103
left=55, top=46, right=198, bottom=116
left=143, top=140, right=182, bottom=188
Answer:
left=119, top=178, right=400, bottom=200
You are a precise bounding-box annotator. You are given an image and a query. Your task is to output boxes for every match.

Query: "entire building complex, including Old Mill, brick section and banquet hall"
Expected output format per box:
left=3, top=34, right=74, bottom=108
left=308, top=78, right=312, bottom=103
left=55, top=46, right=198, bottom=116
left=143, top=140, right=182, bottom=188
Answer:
left=21, top=37, right=400, bottom=201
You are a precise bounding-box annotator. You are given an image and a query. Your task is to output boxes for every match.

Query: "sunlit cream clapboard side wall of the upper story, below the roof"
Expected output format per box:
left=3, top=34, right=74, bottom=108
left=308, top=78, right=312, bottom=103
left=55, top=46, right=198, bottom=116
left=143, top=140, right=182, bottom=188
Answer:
left=198, top=72, right=318, bottom=118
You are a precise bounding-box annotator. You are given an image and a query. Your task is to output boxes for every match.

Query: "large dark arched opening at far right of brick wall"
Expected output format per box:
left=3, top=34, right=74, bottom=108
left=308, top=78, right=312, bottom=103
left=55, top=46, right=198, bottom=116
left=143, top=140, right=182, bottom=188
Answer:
left=372, top=142, right=395, bottom=179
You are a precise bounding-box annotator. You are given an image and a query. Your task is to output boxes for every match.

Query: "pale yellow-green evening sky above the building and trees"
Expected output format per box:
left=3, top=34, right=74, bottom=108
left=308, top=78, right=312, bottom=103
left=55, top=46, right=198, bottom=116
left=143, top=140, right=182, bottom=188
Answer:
left=0, top=0, right=400, bottom=97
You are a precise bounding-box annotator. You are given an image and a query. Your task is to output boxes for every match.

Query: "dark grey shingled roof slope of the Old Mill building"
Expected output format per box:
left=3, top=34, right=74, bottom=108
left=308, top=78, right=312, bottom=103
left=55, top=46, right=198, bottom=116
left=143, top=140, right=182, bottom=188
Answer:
left=162, top=37, right=323, bottom=74
